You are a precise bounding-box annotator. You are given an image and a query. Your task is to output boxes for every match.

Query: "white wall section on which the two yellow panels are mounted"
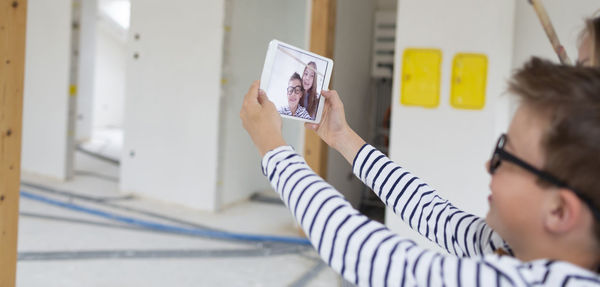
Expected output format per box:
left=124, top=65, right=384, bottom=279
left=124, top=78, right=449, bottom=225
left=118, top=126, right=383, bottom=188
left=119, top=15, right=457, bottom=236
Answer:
left=386, top=0, right=515, bottom=252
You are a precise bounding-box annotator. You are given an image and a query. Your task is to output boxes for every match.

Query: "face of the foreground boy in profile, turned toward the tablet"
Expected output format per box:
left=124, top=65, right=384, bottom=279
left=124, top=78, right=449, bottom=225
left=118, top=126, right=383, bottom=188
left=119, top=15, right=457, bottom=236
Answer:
left=486, top=106, right=552, bottom=248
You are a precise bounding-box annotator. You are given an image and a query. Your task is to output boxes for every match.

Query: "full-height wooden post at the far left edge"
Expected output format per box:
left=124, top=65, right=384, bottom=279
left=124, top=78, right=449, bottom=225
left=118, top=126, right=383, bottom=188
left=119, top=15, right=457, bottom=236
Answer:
left=0, top=0, right=27, bottom=286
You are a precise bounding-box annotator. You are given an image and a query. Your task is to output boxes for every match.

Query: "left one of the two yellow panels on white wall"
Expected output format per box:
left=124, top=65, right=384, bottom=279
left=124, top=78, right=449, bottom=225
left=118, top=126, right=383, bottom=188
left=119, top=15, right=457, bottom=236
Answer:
left=400, top=49, right=442, bottom=108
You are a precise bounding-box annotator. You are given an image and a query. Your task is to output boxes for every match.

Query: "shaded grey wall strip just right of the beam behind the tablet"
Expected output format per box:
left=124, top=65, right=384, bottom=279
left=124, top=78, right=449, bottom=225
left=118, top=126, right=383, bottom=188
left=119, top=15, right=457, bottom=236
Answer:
left=327, top=0, right=376, bottom=206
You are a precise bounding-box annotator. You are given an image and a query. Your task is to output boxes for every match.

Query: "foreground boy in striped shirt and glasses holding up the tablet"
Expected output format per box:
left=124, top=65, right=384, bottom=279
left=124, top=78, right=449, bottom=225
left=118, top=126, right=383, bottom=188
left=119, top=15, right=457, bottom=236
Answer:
left=240, top=58, right=600, bottom=286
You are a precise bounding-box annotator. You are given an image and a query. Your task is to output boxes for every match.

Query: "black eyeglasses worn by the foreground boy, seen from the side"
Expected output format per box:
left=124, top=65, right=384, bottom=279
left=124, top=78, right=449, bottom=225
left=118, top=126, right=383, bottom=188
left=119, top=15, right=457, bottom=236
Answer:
left=490, top=134, right=600, bottom=220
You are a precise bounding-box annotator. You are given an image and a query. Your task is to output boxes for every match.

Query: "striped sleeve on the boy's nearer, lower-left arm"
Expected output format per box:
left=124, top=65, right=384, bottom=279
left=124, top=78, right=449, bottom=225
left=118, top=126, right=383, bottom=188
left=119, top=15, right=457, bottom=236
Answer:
left=262, top=146, right=536, bottom=286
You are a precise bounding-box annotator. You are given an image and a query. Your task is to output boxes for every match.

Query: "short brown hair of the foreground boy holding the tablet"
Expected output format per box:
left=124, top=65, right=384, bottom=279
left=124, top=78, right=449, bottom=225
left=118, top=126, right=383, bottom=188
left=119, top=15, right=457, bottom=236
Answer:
left=508, top=57, right=600, bottom=239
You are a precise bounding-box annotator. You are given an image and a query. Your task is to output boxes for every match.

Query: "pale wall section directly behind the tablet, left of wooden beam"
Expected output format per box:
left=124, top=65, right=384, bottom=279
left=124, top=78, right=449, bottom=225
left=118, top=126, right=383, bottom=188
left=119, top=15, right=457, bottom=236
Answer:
left=217, top=0, right=310, bottom=206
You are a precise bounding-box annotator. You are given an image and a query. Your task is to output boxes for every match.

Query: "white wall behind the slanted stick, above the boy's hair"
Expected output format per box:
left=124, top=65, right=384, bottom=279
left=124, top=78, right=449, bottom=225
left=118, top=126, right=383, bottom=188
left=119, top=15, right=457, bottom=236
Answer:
left=513, top=0, right=600, bottom=67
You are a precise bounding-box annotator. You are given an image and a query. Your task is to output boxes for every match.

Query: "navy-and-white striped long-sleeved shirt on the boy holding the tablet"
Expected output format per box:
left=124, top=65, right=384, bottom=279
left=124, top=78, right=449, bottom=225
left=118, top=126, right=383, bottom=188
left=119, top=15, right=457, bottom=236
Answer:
left=262, top=145, right=600, bottom=286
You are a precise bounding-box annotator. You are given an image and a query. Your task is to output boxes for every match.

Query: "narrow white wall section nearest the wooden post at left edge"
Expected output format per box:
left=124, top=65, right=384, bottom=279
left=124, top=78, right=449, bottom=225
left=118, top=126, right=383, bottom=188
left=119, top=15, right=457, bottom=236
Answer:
left=21, top=0, right=72, bottom=180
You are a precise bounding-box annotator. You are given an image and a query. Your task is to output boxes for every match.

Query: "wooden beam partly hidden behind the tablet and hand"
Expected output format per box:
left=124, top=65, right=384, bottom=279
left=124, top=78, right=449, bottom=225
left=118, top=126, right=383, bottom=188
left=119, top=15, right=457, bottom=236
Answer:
left=304, top=0, right=337, bottom=178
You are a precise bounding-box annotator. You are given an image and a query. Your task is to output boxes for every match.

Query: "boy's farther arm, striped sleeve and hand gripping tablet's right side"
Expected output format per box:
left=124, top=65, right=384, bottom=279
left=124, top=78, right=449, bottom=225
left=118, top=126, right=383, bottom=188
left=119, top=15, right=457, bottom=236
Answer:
left=305, top=91, right=508, bottom=256
